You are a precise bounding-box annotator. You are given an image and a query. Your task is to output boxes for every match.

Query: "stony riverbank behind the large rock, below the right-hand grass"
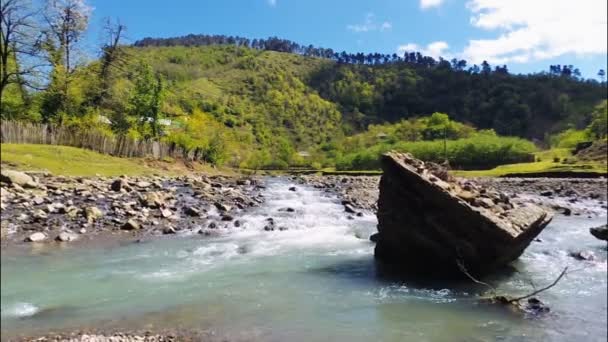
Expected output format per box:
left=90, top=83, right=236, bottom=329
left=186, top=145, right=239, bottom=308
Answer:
left=294, top=175, right=608, bottom=215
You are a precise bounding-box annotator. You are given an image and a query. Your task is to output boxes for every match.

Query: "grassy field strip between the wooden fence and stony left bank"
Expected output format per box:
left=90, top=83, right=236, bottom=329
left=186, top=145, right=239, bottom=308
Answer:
left=0, top=144, right=234, bottom=176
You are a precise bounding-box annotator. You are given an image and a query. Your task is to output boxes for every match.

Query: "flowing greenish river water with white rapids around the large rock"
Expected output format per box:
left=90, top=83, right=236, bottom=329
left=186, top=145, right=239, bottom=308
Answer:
left=1, top=178, right=607, bottom=341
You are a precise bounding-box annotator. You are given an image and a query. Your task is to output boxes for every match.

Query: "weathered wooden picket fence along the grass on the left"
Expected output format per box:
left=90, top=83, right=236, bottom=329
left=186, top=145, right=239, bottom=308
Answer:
left=0, top=120, right=204, bottom=160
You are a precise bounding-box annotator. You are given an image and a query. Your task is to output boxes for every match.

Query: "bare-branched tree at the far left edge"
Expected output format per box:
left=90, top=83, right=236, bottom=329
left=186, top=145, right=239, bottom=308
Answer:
left=0, top=0, right=42, bottom=108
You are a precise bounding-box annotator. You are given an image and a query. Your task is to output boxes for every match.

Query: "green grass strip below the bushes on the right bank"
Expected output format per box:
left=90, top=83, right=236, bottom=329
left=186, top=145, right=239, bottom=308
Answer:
left=453, top=148, right=607, bottom=177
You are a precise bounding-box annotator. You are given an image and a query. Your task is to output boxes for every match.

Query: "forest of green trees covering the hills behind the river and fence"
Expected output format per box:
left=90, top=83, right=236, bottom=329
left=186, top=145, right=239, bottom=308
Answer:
left=0, top=0, right=606, bottom=169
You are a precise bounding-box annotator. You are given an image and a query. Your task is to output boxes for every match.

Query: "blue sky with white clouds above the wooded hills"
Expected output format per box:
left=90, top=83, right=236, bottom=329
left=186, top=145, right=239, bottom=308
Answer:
left=86, top=0, right=608, bottom=78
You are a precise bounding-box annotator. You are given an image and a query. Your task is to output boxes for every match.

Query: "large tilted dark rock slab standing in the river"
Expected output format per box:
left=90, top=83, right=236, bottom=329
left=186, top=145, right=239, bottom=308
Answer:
left=375, top=152, right=553, bottom=275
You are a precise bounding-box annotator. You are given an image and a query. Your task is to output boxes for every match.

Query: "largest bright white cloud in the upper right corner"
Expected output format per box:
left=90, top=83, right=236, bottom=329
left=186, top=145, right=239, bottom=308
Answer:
left=460, top=0, right=608, bottom=64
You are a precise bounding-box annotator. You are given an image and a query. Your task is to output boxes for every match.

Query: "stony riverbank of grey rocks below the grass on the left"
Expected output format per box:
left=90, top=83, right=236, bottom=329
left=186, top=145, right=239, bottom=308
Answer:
left=0, top=170, right=264, bottom=244
